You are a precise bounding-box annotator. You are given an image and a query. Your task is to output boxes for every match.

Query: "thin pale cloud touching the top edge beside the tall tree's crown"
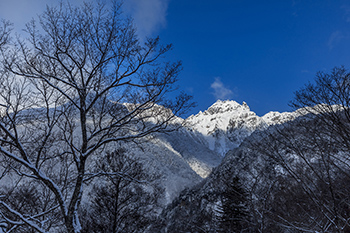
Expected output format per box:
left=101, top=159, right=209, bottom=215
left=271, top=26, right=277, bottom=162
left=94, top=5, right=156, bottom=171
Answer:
left=123, top=0, right=169, bottom=39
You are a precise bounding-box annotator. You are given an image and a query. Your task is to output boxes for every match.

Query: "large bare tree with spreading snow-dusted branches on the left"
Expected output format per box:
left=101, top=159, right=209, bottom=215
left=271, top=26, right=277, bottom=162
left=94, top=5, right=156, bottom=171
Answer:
left=0, top=2, right=192, bottom=233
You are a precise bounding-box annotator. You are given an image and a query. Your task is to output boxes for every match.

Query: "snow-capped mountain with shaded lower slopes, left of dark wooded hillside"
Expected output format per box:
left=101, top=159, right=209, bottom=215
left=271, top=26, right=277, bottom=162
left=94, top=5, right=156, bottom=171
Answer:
left=133, top=100, right=298, bottom=203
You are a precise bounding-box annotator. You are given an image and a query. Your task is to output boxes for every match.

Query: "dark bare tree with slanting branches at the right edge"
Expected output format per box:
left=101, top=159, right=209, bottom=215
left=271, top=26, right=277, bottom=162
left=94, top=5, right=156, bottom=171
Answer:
left=251, top=67, right=350, bottom=232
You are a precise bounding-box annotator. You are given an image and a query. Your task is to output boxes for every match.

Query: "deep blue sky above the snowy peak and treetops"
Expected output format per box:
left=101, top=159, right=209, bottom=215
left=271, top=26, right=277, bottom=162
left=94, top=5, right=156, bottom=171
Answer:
left=0, top=0, right=350, bottom=115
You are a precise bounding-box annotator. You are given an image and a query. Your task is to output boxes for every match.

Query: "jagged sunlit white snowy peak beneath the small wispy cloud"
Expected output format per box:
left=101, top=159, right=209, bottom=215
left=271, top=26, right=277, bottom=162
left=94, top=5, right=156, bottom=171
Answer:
left=186, top=100, right=295, bottom=156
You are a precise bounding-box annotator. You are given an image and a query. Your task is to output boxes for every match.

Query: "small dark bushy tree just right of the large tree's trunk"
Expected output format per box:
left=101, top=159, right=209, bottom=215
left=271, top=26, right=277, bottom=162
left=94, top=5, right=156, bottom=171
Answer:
left=83, top=149, right=163, bottom=233
